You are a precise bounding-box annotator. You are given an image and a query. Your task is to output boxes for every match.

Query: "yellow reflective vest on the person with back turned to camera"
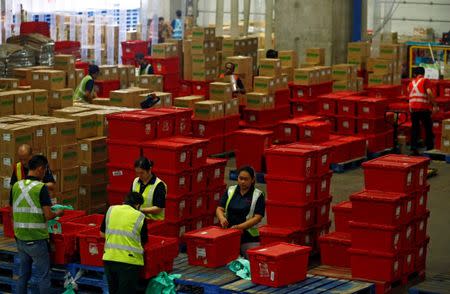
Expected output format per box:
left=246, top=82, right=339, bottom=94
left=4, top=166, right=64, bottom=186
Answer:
left=103, top=204, right=145, bottom=265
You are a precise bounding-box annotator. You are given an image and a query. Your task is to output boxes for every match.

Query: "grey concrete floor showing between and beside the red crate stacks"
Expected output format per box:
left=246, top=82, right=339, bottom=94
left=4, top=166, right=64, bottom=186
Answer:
left=226, top=158, right=450, bottom=293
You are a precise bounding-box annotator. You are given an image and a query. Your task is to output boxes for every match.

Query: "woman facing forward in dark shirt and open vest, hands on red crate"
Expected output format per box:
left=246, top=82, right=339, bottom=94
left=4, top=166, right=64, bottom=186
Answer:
left=216, top=166, right=266, bottom=258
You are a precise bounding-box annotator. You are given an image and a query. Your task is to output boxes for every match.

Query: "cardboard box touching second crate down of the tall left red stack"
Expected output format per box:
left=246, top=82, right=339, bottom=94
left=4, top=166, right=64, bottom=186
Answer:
left=78, top=137, right=108, bottom=164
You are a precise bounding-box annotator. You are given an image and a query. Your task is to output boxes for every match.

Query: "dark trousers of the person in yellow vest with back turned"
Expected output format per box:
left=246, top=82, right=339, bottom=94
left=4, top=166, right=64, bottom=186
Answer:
left=104, top=261, right=142, bottom=294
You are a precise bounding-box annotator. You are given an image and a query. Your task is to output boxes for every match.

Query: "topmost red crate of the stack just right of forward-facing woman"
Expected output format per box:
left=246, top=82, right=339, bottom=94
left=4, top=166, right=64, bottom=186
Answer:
left=265, top=146, right=318, bottom=178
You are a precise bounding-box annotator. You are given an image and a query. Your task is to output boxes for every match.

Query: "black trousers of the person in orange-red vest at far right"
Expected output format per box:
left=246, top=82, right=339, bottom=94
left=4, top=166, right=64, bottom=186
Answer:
left=411, top=110, right=434, bottom=151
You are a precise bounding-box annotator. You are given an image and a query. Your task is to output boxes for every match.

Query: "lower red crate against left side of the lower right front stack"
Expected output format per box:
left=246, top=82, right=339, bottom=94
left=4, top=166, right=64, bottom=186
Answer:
left=318, top=232, right=352, bottom=267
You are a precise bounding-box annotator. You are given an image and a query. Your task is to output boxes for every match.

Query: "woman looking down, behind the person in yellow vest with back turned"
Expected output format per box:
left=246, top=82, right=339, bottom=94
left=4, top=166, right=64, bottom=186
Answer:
left=131, top=157, right=167, bottom=221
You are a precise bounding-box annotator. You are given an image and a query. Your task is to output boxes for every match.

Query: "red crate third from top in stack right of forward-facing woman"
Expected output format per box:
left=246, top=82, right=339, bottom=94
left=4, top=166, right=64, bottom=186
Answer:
left=266, top=200, right=315, bottom=230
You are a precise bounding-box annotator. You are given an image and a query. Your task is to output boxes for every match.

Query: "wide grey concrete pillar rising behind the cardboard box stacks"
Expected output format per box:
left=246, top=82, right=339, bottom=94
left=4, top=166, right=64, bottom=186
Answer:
left=274, top=0, right=353, bottom=65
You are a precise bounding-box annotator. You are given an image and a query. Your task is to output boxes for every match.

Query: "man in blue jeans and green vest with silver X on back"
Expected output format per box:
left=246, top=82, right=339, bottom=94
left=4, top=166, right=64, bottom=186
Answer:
left=10, top=155, right=64, bottom=294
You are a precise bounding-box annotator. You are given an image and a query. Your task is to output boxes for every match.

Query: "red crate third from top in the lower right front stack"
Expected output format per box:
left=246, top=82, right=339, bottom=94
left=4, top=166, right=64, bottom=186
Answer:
left=349, top=221, right=404, bottom=253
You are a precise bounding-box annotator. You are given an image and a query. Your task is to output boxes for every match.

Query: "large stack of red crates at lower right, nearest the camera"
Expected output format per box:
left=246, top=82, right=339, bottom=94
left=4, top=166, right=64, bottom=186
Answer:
left=348, top=155, right=430, bottom=283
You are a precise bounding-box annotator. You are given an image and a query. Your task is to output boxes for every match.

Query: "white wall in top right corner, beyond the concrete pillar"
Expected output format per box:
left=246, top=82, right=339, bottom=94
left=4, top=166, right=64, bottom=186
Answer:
left=368, top=0, right=450, bottom=38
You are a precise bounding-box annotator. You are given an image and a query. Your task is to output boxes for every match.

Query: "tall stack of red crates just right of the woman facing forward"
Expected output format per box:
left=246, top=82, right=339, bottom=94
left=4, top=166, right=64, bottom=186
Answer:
left=260, top=143, right=332, bottom=248
